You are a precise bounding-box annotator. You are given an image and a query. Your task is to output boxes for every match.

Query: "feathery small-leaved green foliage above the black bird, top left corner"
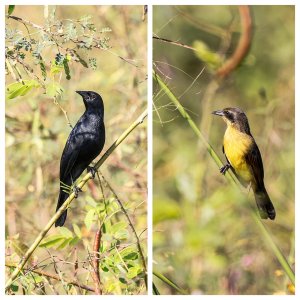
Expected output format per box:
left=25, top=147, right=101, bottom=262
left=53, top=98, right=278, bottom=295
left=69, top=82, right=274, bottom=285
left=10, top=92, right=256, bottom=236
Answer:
left=5, top=5, right=111, bottom=99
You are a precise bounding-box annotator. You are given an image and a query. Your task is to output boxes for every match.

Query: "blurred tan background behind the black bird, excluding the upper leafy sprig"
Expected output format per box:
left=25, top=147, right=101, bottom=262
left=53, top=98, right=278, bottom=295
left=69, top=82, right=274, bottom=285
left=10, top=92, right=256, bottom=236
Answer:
left=6, top=5, right=147, bottom=294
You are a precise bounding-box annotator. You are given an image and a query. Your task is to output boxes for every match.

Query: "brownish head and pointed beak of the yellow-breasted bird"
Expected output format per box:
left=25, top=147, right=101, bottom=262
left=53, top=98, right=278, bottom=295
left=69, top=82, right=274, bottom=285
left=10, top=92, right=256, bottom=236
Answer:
left=212, top=107, right=251, bottom=135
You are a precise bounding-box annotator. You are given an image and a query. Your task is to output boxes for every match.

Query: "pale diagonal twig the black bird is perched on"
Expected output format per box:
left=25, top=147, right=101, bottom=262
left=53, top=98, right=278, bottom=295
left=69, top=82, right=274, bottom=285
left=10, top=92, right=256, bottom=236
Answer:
left=5, top=109, right=147, bottom=290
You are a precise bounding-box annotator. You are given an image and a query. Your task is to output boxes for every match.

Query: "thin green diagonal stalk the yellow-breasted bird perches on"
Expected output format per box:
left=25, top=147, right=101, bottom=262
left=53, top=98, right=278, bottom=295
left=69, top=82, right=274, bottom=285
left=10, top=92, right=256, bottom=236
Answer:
left=153, top=71, right=295, bottom=285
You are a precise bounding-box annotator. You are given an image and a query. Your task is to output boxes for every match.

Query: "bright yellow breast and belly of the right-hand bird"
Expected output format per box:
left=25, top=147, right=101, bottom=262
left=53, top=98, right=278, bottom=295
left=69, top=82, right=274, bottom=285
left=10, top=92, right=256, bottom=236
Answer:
left=224, top=126, right=253, bottom=182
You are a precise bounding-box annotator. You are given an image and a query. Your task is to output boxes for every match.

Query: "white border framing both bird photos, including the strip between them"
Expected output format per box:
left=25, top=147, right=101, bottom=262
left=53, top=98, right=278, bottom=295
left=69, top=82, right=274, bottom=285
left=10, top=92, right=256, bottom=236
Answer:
left=0, top=0, right=300, bottom=300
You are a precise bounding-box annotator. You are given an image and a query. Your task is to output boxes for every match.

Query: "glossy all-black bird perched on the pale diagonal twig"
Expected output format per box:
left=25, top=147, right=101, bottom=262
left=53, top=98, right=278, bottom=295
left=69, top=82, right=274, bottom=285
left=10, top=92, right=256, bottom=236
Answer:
left=55, top=91, right=105, bottom=227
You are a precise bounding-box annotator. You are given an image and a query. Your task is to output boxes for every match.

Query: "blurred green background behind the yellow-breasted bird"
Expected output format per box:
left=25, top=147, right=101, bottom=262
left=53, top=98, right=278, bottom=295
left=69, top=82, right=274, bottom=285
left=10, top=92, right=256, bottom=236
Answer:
left=153, top=6, right=295, bottom=294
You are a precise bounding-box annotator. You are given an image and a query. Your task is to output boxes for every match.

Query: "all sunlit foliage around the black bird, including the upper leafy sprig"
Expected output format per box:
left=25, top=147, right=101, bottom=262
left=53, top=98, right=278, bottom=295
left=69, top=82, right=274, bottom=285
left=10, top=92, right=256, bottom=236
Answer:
left=6, top=6, right=147, bottom=295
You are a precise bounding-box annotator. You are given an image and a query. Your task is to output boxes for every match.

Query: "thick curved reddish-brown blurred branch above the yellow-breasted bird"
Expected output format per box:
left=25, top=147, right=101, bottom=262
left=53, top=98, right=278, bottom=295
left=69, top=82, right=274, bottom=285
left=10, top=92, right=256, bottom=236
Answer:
left=216, top=5, right=252, bottom=78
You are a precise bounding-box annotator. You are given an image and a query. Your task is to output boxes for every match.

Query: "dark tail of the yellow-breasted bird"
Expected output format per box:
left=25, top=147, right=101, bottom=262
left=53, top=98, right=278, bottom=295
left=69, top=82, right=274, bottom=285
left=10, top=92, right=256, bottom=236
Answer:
left=254, top=187, right=276, bottom=220
